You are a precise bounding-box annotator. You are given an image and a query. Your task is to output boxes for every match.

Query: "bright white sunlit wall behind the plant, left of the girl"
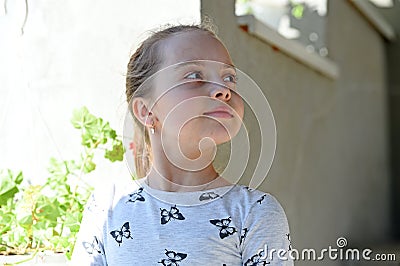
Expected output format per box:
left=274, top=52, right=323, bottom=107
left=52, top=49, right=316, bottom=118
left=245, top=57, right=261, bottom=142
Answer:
left=0, top=0, right=200, bottom=185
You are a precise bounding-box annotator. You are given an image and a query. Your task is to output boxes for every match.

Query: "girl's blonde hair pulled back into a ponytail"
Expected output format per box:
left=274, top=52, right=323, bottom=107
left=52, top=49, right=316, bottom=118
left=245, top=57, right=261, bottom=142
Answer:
left=126, top=21, right=217, bottom=178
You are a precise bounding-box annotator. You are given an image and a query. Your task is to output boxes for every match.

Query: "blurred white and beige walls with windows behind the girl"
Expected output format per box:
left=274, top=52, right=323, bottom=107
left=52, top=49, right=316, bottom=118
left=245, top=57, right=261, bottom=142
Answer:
left=0, top=0, right=400, bottom=265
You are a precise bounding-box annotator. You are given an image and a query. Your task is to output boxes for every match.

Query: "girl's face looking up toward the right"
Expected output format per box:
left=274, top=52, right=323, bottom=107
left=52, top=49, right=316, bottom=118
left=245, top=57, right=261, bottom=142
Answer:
left=151, top=31, right=244, bottom=156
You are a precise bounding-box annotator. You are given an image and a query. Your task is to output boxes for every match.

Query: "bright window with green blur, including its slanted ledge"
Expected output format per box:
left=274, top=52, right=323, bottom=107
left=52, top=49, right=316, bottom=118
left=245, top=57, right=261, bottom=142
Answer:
left=235, top=0, right=339, bottom=79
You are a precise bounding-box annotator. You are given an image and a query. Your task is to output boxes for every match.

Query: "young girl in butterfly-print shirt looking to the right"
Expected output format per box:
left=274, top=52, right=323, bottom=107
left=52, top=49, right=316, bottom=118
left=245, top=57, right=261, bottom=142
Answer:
left=73, top=25, right=293, bottom=266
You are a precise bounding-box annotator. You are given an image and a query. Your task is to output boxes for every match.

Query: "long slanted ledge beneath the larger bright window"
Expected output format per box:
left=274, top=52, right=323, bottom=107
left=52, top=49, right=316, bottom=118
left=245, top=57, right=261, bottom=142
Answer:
left=237, top=15, right=339, bottom=79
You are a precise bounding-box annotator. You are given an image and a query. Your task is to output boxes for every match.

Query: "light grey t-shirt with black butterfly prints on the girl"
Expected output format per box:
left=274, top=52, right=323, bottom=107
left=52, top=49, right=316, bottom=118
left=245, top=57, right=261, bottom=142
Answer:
left=72, top=179, right=293, bottom=266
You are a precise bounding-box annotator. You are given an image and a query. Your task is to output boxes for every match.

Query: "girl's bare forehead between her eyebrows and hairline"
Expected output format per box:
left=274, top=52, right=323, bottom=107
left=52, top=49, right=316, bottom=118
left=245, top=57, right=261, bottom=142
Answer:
left=160, top=31, right=232, bottom=67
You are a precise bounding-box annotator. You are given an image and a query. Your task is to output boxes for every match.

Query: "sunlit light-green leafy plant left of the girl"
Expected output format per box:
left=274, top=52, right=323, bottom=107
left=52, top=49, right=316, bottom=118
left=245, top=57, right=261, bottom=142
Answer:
left=0, top=107, right=124, bottom=258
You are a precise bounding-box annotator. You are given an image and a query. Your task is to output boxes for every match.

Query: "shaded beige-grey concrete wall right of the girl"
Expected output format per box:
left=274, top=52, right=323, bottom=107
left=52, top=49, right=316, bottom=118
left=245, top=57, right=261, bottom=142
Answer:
left=201, top=0, right=390, bottom=265
